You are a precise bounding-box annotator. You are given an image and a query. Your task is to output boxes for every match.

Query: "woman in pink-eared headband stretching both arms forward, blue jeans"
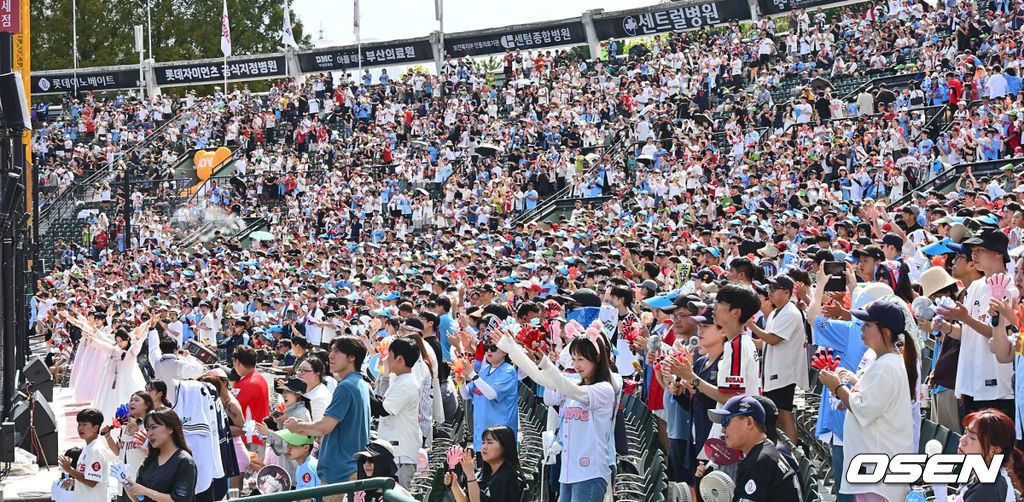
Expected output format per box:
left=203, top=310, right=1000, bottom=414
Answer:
left=498, top=332, right=617, bottom=502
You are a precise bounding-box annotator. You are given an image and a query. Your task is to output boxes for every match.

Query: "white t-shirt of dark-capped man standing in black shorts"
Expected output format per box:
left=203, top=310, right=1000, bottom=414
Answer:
left=762, top=302, right=808, bottom=392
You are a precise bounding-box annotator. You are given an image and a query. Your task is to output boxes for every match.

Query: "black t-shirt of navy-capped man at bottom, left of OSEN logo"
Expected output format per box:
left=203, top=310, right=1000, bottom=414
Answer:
left=732, top=441, right=800, bottom=502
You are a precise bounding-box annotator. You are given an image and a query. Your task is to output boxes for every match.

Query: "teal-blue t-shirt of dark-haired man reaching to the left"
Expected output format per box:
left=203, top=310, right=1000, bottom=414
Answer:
left=316, top=372, right=370, bottom=484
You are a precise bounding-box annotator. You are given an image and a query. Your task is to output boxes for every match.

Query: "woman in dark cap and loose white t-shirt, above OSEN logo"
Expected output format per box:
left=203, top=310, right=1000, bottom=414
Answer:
left=818, top=300, right=918, bottom=502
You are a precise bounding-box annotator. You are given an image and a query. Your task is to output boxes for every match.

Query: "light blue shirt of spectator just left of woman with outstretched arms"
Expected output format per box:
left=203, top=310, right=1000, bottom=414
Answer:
left=467, top=363, right=519, bottom=451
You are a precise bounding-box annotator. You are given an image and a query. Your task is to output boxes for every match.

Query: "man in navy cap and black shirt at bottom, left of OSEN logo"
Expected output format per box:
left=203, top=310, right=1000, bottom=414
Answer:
left=708, top=395, right=802, bottom=502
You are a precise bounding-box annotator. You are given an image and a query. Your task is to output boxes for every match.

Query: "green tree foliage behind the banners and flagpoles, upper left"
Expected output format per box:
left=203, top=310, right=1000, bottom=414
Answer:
left=31, top=0, right=309, bottom=70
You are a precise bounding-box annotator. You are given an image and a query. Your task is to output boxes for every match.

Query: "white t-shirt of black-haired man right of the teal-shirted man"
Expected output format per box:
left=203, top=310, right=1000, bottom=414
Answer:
left=378, top=373, right=423, bottom=463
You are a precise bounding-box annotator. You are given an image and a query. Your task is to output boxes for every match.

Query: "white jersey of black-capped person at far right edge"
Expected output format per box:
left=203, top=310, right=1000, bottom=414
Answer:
left=955, top=279, right=1020, bottom=401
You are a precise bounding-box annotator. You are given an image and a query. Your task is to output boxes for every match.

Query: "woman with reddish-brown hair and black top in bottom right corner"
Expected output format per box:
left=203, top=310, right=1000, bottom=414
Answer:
left=956, top=408, right=1024, bottom=502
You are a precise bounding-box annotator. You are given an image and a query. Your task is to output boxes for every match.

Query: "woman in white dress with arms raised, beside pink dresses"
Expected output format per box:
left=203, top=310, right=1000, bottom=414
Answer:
left=92, top=318, right=147, bottom=417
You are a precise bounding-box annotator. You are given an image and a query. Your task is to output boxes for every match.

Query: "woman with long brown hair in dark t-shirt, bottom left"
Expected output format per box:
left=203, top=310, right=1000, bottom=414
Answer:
left=125, top=407, right=196, bottom=502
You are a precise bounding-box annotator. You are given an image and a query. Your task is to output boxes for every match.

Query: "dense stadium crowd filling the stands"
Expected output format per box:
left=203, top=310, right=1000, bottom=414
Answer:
left=32, top=0, right=1024, bottom=502
